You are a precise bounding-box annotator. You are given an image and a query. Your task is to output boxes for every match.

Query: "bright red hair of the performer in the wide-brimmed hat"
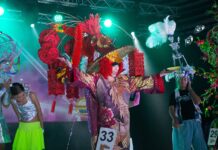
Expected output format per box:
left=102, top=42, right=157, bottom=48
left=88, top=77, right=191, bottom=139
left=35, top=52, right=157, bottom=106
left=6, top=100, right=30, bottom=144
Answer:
left=99, top=57, right=123, bottom=79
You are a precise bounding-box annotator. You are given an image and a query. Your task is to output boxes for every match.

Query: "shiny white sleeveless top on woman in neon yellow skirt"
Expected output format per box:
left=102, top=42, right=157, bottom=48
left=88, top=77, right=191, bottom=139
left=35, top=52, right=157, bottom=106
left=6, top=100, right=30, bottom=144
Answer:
left=13, top=94, right=37, bottom=121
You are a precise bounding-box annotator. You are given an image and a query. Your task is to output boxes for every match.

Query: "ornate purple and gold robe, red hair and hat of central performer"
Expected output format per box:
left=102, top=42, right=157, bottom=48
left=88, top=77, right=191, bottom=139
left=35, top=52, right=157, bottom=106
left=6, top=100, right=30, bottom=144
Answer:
left=75, top=47, right=164, bottom=150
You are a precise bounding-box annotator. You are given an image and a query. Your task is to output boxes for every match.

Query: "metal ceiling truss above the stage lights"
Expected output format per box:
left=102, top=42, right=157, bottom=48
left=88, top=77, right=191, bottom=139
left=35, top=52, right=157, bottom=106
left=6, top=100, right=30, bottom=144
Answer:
left=38, top=0, right=178, bottom=16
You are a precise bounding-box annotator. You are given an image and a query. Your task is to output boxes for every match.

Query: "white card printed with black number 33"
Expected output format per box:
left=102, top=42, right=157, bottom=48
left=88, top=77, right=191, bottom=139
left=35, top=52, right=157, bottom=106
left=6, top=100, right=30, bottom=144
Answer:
left=96, top=127, right=117, bottom=150
